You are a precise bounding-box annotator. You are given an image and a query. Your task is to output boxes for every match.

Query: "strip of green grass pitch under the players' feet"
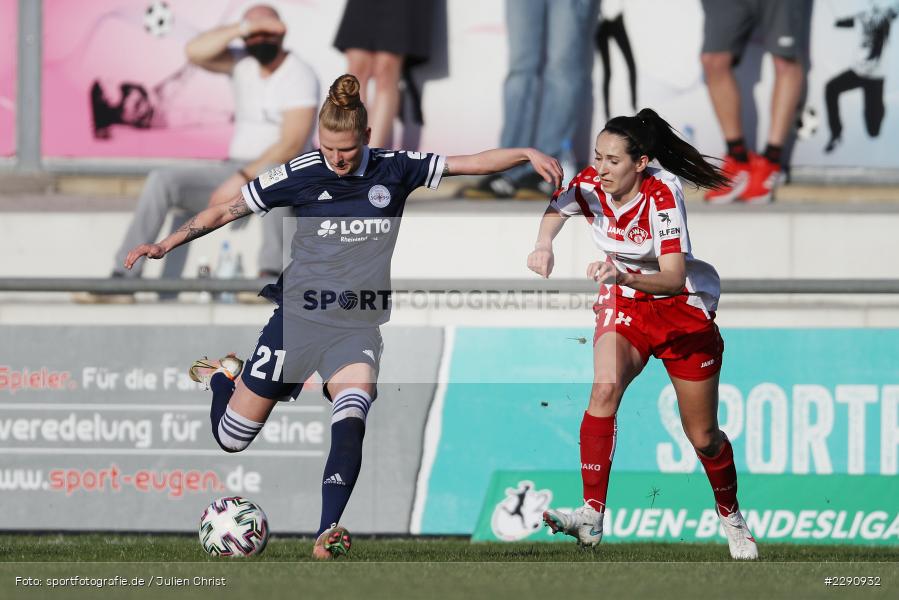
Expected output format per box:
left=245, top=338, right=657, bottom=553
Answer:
left=0, top=534, right=899, bottom=600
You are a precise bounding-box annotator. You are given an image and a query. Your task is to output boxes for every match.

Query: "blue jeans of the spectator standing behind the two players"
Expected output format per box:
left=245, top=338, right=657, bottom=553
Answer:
left=500, top=0, right=599, bottom=180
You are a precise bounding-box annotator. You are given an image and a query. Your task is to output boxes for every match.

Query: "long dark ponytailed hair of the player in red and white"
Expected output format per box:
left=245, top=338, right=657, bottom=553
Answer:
left=603, top=108, right=729, bottom=189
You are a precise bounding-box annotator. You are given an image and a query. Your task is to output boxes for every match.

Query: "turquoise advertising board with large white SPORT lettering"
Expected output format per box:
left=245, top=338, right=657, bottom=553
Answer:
left=420, top=328, right=899, bottom=534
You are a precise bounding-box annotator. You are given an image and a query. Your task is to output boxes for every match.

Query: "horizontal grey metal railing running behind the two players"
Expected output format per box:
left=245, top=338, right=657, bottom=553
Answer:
left=0, top=277, right=899, bottom=294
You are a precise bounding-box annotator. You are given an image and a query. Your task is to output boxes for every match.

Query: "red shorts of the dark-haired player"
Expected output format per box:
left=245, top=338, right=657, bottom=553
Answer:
left=593, top=296, right=724, bottom=381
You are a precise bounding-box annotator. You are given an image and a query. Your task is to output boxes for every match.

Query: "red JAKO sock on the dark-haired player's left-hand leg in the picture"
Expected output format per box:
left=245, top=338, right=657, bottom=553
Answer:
left=581, top=412, right=618, bottom=511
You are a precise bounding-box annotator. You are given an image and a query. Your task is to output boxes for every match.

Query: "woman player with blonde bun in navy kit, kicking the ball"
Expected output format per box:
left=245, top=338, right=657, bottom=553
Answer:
left=125, top=75, right=562, bottom=559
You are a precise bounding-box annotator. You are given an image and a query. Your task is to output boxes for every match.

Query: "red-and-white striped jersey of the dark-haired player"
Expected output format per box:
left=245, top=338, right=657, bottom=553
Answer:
left=550, top=167, right=721, bottom=313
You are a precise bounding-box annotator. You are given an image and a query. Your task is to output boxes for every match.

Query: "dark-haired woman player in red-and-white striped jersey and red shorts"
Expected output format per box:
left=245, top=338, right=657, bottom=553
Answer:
left=528, top=109, right=758, bottom=559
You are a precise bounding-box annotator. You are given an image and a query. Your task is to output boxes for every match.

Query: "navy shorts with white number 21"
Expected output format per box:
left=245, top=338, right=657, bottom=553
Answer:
left=241, top=306, right=384, bottom=400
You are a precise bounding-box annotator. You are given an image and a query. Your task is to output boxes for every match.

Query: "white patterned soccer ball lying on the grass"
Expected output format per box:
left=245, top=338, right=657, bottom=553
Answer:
left=200, top=496, right=268, bottom=557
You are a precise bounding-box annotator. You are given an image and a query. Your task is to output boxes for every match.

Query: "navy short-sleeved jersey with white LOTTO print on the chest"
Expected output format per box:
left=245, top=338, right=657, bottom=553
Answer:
left=241, top=146, right=446, bottom=327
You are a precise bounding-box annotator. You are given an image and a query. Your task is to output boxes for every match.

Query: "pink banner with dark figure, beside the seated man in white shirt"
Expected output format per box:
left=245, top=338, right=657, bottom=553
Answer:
left=40, top=0, right=245, bottom=158
